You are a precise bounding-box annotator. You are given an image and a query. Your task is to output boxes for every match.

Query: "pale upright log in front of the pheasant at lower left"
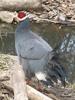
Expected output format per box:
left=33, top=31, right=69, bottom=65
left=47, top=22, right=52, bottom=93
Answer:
left=11, top=59, right=28, bottom=100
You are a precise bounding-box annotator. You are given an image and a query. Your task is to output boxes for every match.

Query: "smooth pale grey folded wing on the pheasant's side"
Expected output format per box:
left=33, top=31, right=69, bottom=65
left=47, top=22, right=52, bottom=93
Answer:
left=19, top=39, right=48, bottom=60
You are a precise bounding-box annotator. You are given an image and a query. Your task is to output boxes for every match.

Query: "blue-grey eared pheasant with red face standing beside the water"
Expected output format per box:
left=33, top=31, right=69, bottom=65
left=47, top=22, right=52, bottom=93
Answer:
left=15, top=11, right=66, bottom=86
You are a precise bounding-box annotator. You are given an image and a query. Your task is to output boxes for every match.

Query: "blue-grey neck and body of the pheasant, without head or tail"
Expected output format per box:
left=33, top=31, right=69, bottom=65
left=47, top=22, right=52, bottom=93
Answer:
left=15, top=18, right=64, bottom=85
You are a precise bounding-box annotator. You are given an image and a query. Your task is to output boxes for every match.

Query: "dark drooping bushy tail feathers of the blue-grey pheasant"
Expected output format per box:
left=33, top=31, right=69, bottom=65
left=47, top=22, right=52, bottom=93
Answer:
left=46, top=59, right=66, bottom=87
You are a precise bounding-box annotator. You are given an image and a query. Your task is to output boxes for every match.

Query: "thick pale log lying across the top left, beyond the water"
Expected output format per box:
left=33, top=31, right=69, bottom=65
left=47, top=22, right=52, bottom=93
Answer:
left=0, top=0, right=41, bottom=10
